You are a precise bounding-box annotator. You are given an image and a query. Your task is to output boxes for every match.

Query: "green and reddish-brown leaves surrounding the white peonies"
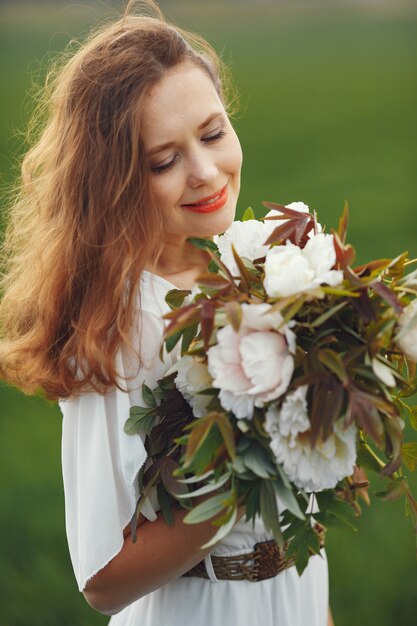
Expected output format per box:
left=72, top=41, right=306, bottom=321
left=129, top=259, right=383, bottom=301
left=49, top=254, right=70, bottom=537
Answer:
left=126, top=203, right=417, bottom=574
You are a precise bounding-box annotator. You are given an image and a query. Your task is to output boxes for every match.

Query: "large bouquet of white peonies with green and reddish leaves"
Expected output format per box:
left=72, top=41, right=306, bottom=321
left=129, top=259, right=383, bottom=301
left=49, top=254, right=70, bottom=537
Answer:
left=125, top=202, right=417, bottom=574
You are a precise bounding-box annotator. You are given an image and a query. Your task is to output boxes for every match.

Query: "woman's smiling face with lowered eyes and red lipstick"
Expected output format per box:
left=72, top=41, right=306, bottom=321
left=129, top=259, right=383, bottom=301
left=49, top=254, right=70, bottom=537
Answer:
left=141, top=61, right=242, bottom=242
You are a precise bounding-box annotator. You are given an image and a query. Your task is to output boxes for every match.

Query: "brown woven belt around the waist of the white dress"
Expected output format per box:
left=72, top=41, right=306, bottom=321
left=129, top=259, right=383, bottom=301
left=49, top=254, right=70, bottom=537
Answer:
left=184, top=524, right=326, bottom=582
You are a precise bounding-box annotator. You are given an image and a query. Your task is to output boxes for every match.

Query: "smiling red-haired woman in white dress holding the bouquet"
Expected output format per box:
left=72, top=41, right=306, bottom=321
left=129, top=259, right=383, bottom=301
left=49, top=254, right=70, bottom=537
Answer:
left=0, top=2, right=330, bottom=626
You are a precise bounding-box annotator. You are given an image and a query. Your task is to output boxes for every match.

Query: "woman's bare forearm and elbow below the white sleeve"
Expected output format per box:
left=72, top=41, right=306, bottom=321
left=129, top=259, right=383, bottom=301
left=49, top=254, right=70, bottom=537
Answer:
left=83, top=508, right=244, bottom=615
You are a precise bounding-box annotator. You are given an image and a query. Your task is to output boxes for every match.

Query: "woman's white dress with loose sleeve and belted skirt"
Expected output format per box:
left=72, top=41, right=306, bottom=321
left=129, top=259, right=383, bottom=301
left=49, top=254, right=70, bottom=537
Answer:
left=60, top=272, right=328, bottom=626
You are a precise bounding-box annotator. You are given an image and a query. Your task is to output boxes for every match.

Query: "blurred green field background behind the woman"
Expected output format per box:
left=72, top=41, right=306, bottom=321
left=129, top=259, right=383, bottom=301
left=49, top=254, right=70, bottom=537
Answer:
left=0, top=0, right=417, bottom=626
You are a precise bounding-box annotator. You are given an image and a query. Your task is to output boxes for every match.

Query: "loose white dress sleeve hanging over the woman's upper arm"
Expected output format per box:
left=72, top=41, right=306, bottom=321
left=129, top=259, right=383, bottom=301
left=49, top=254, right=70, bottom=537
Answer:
left=59, top=311, right=171, bottom=591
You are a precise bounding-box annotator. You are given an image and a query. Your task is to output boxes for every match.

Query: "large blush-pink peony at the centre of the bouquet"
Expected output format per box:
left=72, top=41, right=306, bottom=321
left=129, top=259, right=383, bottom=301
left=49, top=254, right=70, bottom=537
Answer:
left=207, top=304, right=295, bottom=418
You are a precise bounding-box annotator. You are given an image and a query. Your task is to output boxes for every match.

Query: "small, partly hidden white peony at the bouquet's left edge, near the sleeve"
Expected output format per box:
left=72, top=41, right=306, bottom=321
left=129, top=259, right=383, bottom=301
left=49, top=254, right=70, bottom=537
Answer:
left=175, top=355, right=212, bottom=417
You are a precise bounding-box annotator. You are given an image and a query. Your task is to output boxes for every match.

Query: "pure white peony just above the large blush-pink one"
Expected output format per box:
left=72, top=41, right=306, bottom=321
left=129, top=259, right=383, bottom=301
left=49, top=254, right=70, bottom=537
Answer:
left=264, top=233, right=343, bottom=298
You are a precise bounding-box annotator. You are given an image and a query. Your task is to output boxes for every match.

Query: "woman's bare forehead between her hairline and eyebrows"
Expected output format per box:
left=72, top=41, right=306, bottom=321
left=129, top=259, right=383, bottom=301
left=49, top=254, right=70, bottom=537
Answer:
left=141, top=62, right=225, bottom=147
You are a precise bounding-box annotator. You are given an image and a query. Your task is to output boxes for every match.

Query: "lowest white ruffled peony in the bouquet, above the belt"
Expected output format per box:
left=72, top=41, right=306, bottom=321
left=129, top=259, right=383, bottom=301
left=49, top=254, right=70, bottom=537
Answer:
left=265, top=387, right=356, bottom=491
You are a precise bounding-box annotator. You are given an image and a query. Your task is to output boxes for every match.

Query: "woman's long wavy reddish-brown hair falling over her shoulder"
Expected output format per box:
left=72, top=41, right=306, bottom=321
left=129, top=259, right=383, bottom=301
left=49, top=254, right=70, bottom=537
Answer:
left=0, top=1, right=234, bottom=399
